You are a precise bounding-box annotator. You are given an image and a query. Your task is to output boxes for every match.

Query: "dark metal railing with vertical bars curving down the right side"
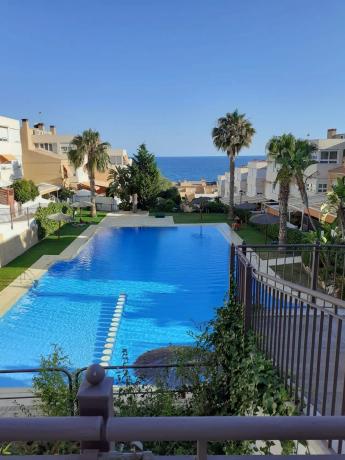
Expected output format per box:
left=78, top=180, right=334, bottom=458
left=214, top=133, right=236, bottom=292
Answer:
left=232, top=246, right=345, bottom=453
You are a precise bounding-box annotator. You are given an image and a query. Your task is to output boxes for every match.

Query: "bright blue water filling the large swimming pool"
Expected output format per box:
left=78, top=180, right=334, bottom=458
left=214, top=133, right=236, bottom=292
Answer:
left=0, top=226, right=229, bottom=386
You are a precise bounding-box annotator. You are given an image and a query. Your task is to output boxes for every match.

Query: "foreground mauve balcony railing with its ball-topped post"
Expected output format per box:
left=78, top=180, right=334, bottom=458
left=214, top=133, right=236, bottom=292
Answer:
left=0, top=365, right=345, bottom=460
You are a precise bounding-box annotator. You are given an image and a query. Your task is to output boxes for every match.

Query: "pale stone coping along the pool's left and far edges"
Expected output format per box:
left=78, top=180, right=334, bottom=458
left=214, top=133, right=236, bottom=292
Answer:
left=0, top=213, right=234, bottom=318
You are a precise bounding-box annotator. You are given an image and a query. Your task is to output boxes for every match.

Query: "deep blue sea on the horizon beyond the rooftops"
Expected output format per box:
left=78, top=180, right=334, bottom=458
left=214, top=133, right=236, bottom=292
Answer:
left=156, top=155, right=265, bottom=182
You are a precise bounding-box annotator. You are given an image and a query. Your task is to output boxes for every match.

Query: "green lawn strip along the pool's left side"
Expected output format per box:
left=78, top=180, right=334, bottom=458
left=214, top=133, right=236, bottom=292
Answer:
left=0, top=210, right=106, bottom=291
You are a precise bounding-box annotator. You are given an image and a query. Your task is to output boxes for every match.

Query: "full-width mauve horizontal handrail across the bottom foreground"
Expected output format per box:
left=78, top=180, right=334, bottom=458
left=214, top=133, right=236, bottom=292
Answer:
left=0, top=416, right=345, bottom=442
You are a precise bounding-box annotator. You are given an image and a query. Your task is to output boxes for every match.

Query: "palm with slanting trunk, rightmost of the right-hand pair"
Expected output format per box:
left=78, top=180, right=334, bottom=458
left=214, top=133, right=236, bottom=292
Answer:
left=292, top=139, right=317, bottom=231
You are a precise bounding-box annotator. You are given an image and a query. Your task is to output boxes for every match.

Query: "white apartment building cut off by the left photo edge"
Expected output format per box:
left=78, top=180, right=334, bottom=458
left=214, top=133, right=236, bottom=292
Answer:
left=0, top=116, right=23, bottom=187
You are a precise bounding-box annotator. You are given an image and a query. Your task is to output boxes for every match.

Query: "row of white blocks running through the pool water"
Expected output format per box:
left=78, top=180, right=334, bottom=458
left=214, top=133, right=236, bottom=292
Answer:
left=95, top=293, right=127, bottom=367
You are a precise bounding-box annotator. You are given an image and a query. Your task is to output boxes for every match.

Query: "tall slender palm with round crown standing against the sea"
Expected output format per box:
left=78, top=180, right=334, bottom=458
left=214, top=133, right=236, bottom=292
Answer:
left=212, top=110, right=255, bottom=222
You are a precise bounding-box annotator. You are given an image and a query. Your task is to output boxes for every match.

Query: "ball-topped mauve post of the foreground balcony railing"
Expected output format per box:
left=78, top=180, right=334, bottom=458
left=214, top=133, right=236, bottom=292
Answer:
left=77, top=364, right=114, bottom=452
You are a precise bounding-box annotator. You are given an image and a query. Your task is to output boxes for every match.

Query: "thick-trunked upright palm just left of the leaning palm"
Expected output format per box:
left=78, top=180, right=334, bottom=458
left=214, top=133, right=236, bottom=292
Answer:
left=267, top=134, right=296, bottom=244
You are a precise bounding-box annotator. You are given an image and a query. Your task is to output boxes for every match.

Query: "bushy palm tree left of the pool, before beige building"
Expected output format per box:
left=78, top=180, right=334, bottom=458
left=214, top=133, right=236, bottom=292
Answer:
left=67, top=129, right=110, bottom=217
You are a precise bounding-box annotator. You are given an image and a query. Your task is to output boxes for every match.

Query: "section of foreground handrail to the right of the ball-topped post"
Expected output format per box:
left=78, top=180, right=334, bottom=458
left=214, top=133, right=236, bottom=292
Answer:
left=105, top=416, right=345, bottom=441
